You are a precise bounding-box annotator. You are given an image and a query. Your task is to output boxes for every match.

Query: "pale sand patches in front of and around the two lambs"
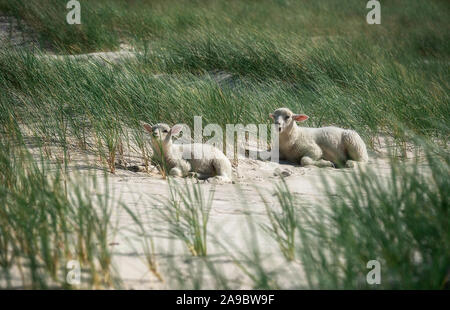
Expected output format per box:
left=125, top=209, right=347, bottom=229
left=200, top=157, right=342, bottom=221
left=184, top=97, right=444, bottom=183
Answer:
left=21, top=136, right=396, bottom=289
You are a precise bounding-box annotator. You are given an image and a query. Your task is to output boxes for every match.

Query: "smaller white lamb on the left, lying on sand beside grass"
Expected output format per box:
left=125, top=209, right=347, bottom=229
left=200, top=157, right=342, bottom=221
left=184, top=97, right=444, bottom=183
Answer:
left=143, top=123, right=232, bottom=183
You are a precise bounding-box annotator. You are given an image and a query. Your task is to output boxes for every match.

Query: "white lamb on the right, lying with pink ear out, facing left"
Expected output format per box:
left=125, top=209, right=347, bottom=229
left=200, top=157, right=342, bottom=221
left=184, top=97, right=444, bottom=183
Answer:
left=269, top=108, right=369, bottom=168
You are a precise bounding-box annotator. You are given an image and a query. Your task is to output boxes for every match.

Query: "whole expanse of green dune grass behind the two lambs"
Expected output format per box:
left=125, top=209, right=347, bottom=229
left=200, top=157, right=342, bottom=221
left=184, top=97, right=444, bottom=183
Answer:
left=0, top=0, right=450, bottom=149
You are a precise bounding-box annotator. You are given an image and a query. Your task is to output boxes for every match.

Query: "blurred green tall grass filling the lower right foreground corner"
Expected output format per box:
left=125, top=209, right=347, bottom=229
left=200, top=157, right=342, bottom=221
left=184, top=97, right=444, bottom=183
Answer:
left=181, top=141, right=450, bottom=289
